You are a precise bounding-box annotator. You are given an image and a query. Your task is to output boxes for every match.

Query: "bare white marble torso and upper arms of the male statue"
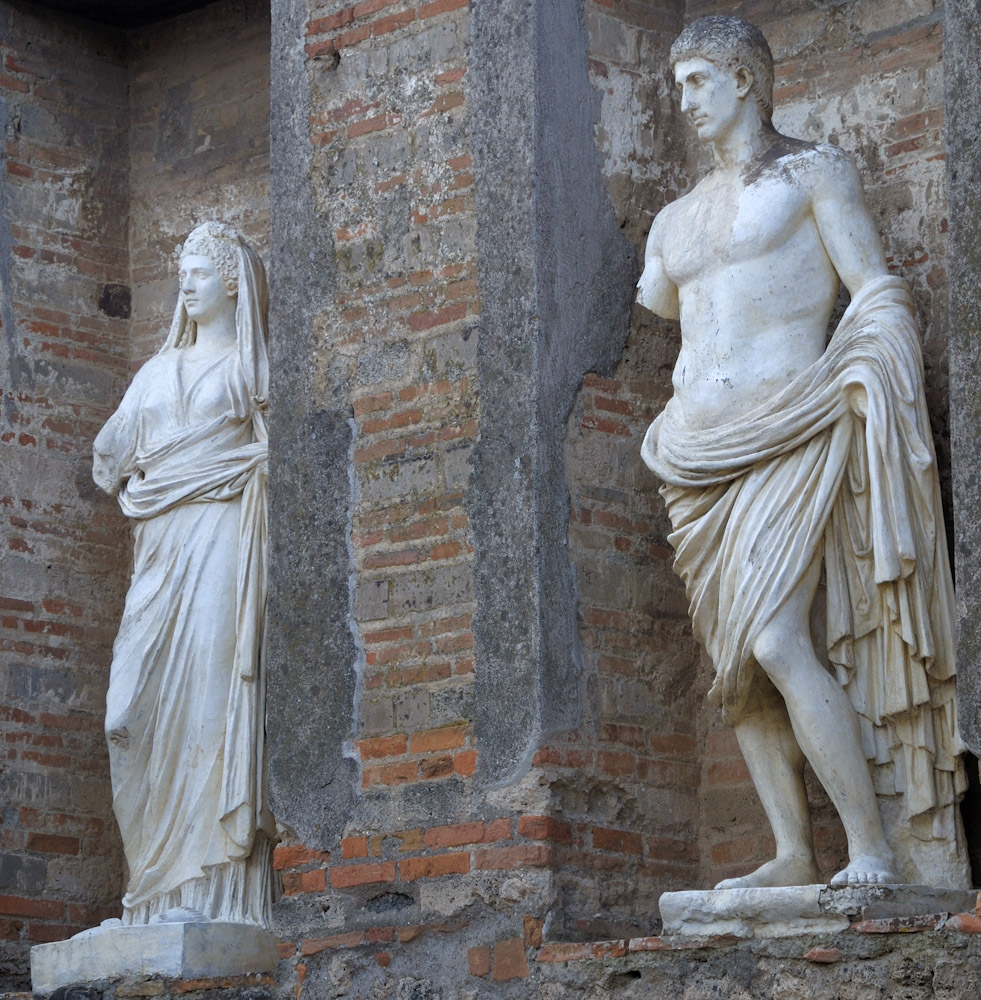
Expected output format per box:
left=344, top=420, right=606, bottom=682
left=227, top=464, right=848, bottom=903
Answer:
left=640, top=132, right=886, bottom=427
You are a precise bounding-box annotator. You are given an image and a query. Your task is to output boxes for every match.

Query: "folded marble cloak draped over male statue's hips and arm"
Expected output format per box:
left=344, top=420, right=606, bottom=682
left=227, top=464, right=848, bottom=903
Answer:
left=642, top=276, right=966, bottom=838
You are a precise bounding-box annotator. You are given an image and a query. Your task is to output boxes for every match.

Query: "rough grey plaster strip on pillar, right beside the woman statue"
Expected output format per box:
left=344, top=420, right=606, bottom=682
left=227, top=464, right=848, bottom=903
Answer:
left=266, top=0, right=363, bottom=847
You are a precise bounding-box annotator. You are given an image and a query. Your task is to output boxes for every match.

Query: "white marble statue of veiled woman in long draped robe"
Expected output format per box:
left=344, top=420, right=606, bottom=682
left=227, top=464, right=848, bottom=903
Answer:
left=93, top=222, right=275, bottom=927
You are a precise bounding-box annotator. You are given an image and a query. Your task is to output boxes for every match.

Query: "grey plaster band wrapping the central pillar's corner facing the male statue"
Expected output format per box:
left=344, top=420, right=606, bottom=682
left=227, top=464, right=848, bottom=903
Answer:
left=467, top=0, right=633, bottom=782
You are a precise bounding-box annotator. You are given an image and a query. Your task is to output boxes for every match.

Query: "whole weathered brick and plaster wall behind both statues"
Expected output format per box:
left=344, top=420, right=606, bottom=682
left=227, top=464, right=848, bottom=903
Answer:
left=0, top=0, right=981, bottom=1000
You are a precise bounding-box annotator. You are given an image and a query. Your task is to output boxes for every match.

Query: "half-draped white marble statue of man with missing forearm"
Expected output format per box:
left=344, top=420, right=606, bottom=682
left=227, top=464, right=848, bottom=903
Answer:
left=639, top=16, right=969, bottom=888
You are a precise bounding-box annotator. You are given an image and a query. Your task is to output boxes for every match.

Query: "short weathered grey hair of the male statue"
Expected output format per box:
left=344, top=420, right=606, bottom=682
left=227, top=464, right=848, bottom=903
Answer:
left=669, top=15, right=773, bottom=122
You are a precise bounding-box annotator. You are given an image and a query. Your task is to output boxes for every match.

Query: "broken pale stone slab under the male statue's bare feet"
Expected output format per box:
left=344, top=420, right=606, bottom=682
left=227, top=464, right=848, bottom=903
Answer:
left=659, top=885, right=978, bottom=938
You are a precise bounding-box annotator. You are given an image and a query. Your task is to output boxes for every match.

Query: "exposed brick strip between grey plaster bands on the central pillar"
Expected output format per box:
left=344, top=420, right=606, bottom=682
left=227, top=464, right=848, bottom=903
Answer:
left=307, top=0, right=480, bottom=816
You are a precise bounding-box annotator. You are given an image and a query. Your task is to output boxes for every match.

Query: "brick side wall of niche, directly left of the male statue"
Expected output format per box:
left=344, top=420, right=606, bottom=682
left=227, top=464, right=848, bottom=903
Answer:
left=539, top=0, right=705, bottom=938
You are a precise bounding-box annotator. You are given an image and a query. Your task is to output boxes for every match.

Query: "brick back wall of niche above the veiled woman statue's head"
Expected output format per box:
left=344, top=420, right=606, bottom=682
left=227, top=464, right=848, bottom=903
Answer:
left=127, top=0, right=269, bottom=370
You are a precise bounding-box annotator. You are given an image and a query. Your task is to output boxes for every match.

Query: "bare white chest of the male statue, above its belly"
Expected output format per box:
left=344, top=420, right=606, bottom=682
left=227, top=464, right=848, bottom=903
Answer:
left=662, top=175, right=819, bottom=288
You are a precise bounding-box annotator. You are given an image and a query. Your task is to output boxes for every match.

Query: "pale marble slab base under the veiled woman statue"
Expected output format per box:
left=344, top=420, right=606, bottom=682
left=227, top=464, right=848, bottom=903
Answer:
left=31, top=921, right=279, bottom=993
